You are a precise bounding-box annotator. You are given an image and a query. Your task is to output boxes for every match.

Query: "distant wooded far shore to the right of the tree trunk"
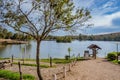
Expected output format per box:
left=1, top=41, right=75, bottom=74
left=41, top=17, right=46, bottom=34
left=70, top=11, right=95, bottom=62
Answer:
left=46, top=32, right=120, bottom=42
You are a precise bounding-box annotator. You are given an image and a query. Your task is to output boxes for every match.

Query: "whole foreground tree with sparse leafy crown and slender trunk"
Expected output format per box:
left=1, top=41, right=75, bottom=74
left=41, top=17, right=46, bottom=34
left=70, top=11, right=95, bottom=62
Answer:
left=1, top=0, right=91, bottom=80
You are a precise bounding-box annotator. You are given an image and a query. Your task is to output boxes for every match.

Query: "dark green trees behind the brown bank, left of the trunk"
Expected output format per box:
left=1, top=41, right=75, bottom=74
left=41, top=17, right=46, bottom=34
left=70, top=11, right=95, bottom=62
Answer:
left=0, top=27, right=31, bottom=41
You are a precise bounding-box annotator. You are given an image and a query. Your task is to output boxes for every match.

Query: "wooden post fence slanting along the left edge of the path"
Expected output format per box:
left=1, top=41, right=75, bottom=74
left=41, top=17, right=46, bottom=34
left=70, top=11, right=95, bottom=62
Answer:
left=44, top=55, right=79, bottom=80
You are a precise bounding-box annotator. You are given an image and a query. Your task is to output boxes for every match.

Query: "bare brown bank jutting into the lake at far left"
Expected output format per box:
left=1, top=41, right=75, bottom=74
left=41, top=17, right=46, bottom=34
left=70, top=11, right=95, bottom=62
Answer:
left=0, top=39, right=28, bottom=44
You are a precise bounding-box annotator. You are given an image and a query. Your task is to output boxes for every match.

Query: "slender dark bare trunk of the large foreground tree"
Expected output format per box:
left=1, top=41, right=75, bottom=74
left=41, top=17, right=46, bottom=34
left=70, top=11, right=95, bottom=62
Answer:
left=36, top=41, right=43, bottom=80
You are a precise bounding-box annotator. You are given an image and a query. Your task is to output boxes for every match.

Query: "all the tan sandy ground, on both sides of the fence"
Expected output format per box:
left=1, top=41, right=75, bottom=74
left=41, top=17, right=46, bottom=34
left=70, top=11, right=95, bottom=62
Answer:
left=0, top=59, right=120, bottom=80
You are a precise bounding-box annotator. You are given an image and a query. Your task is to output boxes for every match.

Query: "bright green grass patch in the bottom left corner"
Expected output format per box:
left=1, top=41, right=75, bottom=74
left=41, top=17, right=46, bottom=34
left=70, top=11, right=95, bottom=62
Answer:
left=0, top=70, right=35, bottom=80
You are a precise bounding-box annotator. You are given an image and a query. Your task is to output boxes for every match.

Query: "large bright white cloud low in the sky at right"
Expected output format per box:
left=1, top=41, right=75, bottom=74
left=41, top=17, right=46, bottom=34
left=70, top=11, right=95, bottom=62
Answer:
left=91, top=11, right=120, bottom=28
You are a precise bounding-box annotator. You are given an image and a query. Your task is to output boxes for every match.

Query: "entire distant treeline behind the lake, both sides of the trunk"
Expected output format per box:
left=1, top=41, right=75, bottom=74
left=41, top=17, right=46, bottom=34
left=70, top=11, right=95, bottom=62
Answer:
left=0, top=27, right=120, bottom=42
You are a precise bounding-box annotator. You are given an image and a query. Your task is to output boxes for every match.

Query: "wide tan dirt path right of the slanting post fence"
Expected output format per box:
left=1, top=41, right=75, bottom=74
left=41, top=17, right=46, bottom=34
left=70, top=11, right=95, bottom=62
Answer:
left=66, top=59, right=120, bottom=80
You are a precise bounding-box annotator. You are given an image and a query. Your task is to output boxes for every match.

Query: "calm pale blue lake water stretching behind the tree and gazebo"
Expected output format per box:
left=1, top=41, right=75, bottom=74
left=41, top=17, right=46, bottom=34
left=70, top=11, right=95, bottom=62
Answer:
left=0, top=40, right=120, bottom=58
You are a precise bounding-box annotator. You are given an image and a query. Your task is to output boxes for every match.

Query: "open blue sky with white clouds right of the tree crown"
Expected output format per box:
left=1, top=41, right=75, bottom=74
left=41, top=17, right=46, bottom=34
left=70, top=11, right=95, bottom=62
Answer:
left=74, top=0, right=120, bottom=34
